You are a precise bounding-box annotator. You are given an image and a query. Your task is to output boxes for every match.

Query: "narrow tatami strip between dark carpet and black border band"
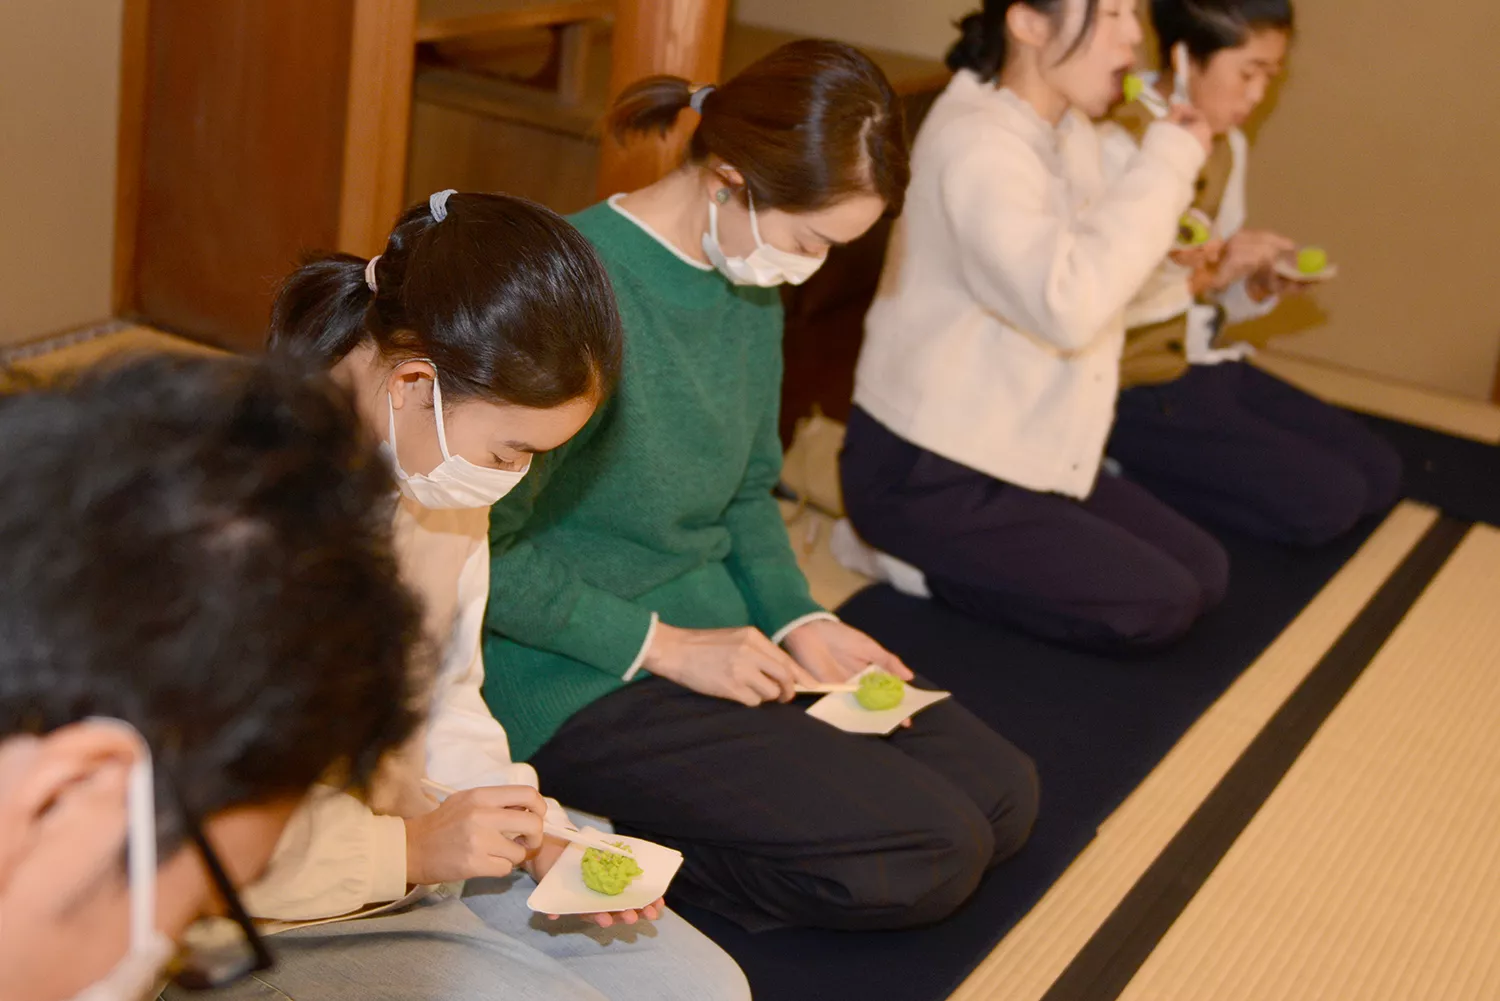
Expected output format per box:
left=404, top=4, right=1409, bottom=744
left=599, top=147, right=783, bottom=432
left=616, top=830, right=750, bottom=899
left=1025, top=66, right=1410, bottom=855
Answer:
left=953, top=503, right=1436, bottom=1001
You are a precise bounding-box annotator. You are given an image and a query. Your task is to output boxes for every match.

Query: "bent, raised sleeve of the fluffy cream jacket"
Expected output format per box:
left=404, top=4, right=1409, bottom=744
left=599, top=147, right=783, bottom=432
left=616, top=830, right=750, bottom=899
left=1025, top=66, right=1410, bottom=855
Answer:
left=941, top=122, right=1206, bottom=351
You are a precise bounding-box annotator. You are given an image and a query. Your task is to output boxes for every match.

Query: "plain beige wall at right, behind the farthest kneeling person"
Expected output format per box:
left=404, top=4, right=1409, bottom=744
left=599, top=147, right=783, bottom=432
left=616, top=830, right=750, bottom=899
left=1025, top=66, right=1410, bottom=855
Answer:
left=1250, top=0, right=1500, bottom=399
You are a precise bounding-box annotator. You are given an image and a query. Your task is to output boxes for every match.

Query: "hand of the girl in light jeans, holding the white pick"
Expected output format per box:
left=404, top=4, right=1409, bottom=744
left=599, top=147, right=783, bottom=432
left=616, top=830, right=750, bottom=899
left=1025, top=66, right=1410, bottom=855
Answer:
left=407, top=785, right=548, bottom=885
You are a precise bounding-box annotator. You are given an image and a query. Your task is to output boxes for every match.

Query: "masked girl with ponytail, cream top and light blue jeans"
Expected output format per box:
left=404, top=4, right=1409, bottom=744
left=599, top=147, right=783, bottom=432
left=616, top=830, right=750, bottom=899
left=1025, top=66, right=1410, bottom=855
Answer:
left=178, top=191, right=749, bottom=1001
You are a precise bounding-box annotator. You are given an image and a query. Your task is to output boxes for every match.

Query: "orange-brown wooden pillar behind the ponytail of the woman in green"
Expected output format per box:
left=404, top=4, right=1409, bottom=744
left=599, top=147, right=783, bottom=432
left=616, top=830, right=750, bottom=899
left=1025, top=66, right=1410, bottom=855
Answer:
left=599, top=0, right=729, bottom=197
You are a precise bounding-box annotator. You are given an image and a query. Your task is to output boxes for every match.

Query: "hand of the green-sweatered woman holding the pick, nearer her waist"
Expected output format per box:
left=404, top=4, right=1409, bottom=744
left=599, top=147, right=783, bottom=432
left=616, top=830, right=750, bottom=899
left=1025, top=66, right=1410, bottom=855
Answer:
left=644, top=623, right=815, bottom=705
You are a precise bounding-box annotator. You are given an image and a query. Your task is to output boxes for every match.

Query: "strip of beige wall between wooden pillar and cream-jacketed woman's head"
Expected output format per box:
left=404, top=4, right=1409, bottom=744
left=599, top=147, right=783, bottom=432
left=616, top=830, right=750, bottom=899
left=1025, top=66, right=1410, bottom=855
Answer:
left=734, top=0, right=980, bottom=59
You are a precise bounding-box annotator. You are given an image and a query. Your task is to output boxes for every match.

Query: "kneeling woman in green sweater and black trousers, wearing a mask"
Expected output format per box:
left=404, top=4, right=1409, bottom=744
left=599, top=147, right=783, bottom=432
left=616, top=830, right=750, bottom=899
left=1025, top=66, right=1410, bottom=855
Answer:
left=485, top=42, right=1037, bottom=929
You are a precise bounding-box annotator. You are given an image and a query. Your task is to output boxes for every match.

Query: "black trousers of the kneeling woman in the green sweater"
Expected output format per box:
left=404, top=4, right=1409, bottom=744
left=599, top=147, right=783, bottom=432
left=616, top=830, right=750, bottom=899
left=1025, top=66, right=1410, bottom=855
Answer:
left=531, top=678, right=1038, bottom=930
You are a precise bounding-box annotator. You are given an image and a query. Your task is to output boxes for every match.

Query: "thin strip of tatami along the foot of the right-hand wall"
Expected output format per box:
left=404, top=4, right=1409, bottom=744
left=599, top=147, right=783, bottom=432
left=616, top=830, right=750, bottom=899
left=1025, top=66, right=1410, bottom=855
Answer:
left=1256, top=351, right=1500, bottom=444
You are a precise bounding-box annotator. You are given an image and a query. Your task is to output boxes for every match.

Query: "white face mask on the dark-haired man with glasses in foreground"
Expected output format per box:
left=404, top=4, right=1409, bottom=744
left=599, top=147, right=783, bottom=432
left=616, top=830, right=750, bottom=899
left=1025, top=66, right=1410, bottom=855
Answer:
left=72, top=720, right=177, bottom=1001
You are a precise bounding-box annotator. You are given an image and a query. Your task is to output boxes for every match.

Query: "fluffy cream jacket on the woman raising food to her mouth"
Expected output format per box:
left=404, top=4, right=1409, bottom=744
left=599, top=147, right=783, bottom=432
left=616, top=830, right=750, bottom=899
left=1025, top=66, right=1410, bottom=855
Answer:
left=855, top=71, right=1205, bottom=497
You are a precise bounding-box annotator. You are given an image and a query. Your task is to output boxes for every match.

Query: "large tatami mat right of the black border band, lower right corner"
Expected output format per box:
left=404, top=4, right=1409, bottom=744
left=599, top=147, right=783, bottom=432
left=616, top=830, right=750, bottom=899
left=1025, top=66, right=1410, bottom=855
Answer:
left=1122, top=527, right=1500, bottom=1001
